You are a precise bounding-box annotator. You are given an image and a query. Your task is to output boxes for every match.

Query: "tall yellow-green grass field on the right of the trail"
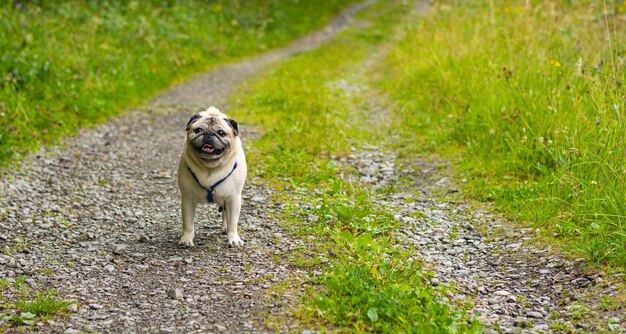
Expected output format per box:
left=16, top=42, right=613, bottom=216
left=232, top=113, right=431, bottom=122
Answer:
left=379, top=1, right=626, bottom=268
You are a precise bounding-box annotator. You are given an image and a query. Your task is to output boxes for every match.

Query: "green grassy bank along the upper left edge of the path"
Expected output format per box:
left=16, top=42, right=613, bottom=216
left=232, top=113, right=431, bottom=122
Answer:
left=0, top=0, right=354, bottom=163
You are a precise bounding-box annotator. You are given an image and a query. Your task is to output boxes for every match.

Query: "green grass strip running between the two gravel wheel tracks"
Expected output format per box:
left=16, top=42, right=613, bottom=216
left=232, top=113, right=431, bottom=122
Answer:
left=230, top=1, right=479, bottom=333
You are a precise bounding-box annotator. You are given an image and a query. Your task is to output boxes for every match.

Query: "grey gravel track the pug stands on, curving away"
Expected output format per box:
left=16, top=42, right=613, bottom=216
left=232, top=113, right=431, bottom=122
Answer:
left=0, top=1, right=373, bottom=333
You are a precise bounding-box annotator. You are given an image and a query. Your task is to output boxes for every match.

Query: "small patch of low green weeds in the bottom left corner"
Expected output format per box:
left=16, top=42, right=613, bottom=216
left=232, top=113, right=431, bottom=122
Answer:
left=0, top=277, right=73, bottom=330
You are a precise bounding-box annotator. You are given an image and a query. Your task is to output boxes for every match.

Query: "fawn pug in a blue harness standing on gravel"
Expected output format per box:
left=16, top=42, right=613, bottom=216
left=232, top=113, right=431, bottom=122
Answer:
left=178, top=106, right=247, bottom=247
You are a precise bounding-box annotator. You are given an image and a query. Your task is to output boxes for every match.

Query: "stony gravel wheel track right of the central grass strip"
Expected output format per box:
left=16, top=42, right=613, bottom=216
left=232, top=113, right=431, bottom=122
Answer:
left=340, top=146, right=626, bottom=333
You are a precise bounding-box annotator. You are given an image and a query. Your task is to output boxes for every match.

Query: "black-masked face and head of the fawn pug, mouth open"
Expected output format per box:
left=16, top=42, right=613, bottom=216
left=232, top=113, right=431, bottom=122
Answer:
left=186, top=107, right=239, bottom=163
